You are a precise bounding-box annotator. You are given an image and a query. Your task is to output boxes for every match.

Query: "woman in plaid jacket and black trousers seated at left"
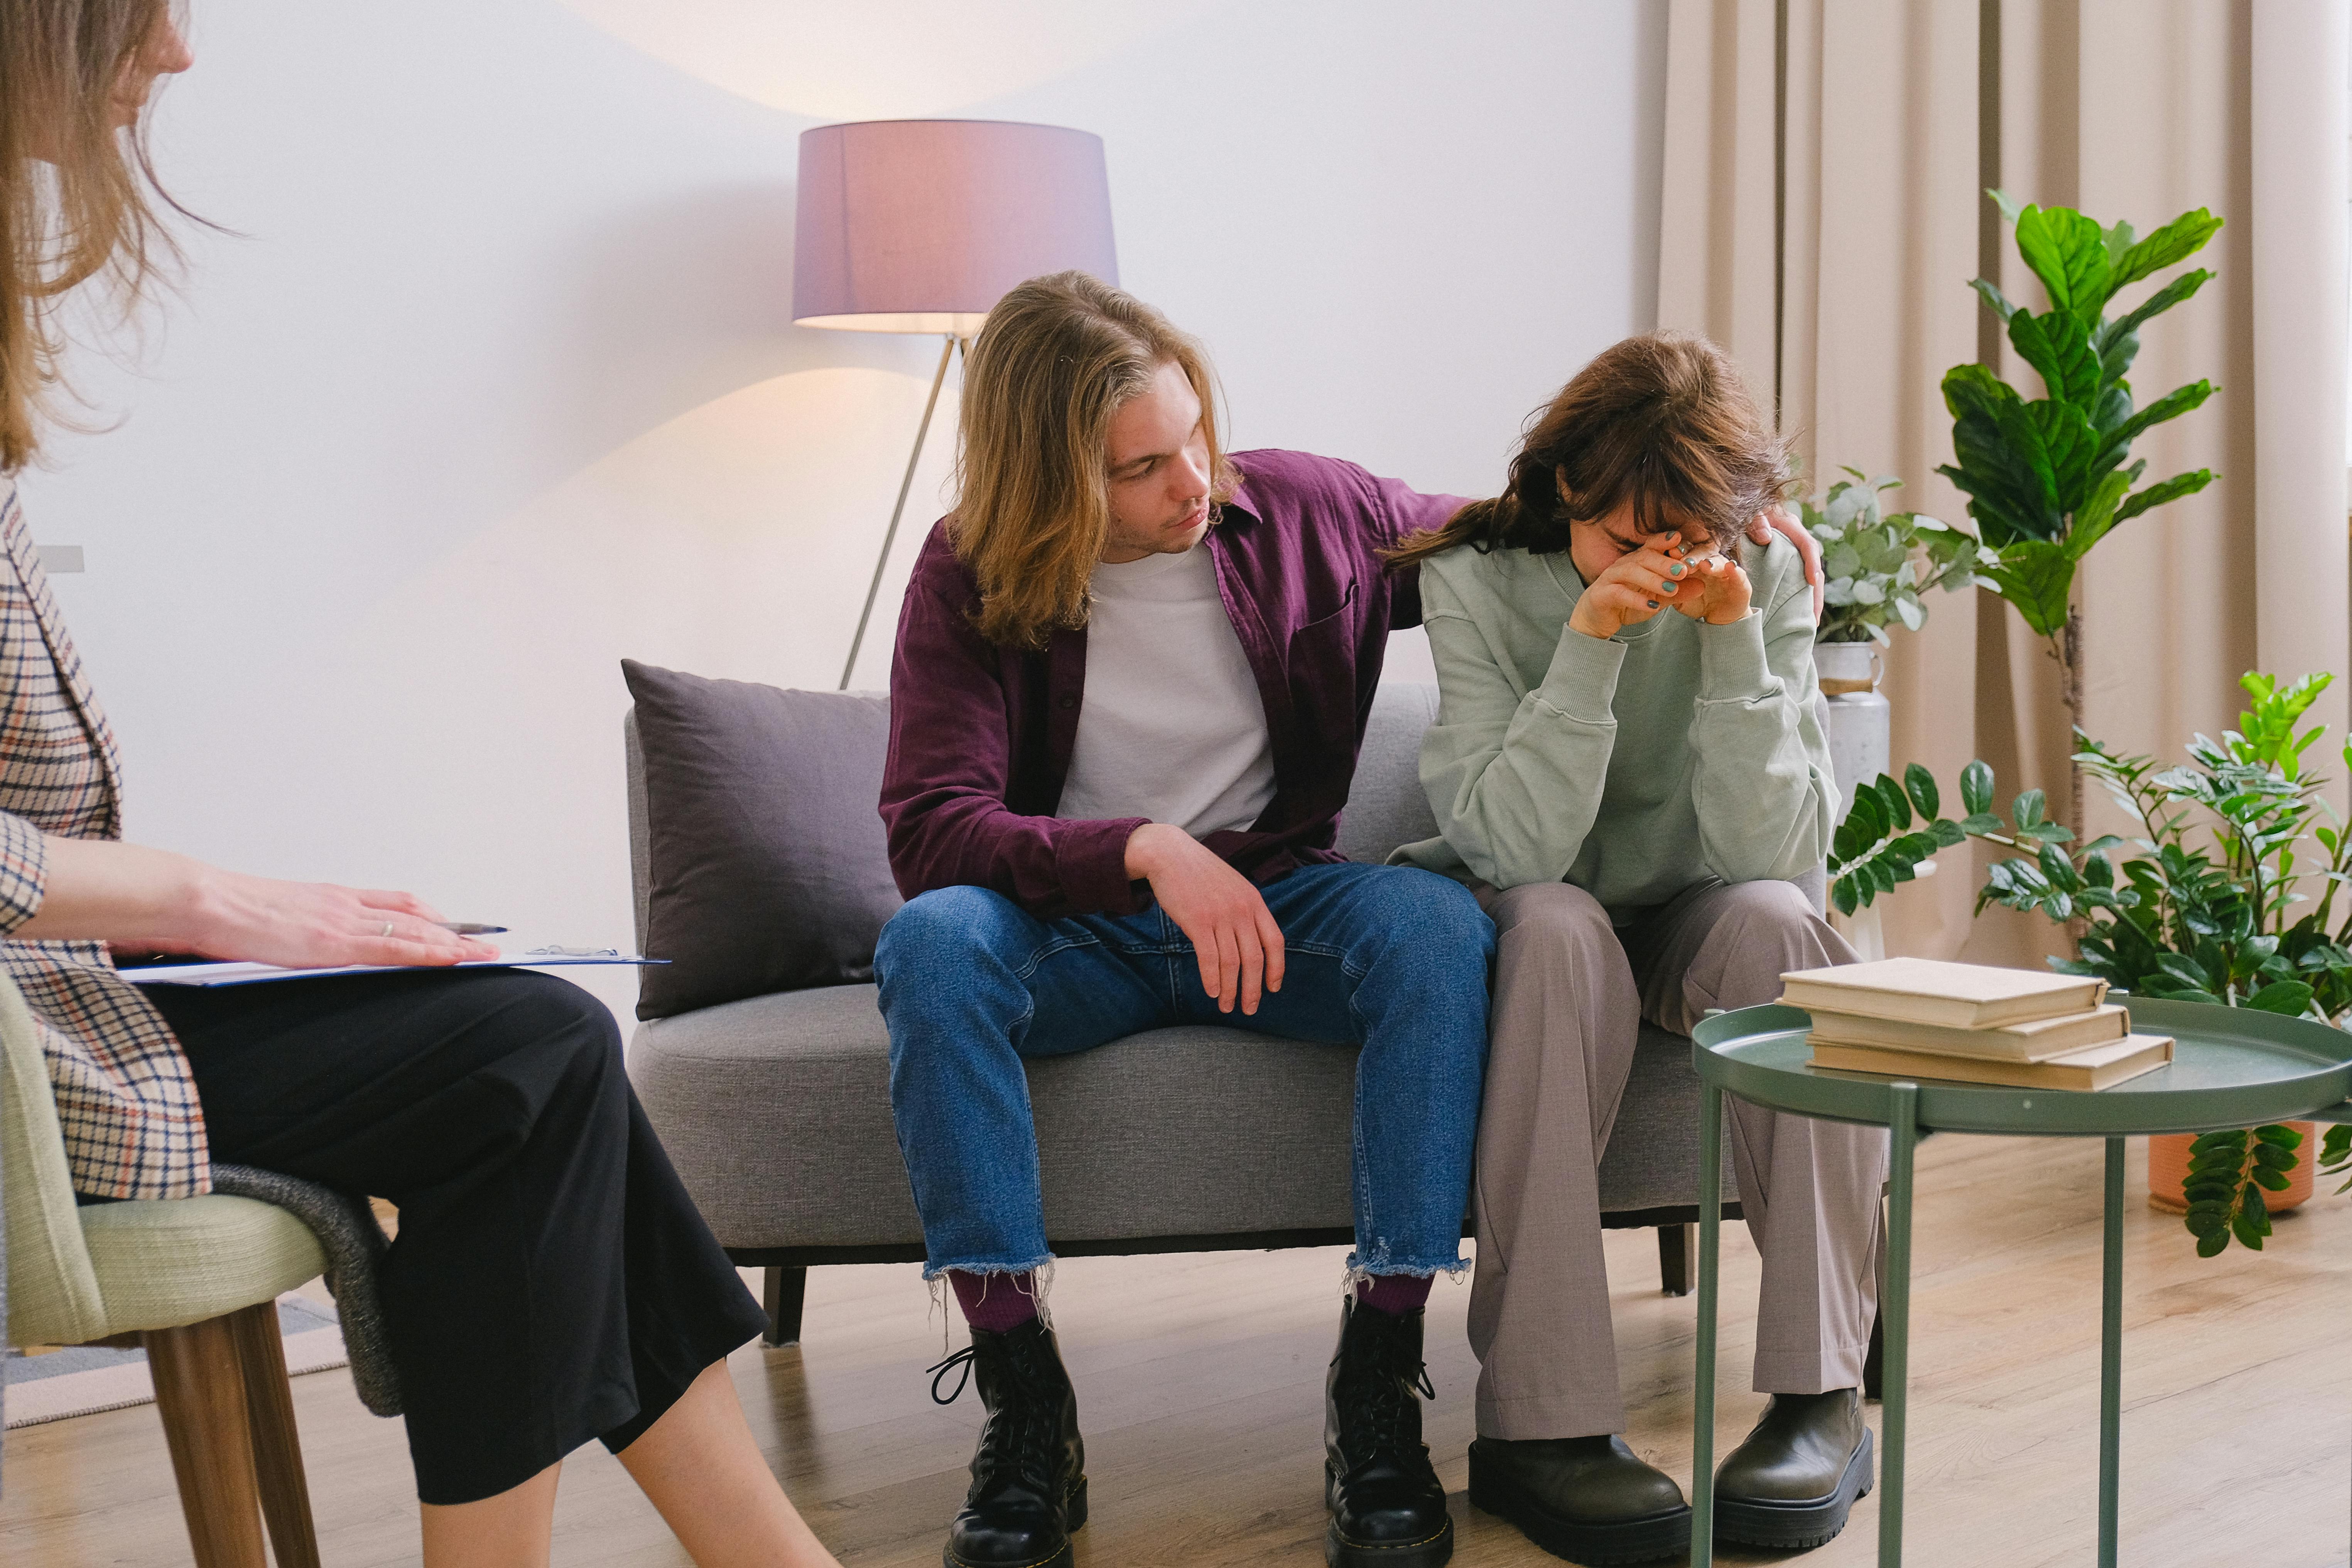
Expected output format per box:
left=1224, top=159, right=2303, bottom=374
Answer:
left=0, top=0, right=832, bottom=1568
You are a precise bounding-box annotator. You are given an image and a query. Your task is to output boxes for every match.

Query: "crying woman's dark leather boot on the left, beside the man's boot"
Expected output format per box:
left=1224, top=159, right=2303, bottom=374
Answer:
left=1470, top=1436, right=1691, bottom=1568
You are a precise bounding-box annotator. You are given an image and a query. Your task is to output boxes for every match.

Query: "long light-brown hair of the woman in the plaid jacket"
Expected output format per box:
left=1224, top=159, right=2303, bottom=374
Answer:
left=0, top=0, right=179, bottom=473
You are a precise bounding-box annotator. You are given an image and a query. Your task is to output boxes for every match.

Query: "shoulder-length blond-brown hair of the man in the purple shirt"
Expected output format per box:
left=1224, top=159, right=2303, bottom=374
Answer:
left=948, top=273, right=1235, bottom=649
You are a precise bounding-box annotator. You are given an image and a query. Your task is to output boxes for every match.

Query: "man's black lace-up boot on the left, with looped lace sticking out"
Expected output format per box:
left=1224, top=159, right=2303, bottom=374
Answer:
left=931, top=1319, right=1087, bottom=1568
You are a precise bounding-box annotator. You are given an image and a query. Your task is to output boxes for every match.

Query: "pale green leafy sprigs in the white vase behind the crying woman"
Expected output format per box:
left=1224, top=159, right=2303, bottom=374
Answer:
left=1797, top=468, right=1978, bottom=644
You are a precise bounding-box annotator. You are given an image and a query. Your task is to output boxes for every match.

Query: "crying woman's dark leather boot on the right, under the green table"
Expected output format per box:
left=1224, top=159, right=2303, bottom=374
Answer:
left=1715, top=1389, right=1872, bottom=1551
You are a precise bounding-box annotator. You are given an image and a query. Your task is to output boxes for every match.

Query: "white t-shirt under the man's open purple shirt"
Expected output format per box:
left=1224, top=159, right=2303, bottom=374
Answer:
left=1054, top=543, right=1275, bottom=837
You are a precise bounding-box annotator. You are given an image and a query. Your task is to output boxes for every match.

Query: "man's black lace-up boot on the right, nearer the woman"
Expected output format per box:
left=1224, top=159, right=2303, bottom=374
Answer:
left=1324, top=1295, right=1454, bottom=1568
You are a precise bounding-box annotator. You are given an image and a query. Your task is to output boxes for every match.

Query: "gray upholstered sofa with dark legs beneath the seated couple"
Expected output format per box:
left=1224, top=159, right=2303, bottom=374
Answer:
left=623, top=684, right=1759, bottom=1345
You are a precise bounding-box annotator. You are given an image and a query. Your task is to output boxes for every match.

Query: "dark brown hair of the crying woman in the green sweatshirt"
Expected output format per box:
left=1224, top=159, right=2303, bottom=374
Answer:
left=1388, top=331, right=1792, bottom=567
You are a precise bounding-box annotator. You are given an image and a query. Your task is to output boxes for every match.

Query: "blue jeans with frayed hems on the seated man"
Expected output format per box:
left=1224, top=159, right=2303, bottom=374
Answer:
left=875, top=865, right=1494, bottom=1279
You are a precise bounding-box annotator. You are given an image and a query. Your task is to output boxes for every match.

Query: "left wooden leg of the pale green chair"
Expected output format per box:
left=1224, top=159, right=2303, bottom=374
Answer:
left=146, top=1317, right=266, bottom=1568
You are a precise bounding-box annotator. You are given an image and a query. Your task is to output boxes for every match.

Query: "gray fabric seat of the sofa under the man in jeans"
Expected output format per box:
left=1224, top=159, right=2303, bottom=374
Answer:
left=628, top=985, right=1355, bottom=1248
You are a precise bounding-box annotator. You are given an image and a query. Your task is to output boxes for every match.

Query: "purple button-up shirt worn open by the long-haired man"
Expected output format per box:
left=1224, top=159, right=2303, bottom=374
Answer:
left=882, top=451, right=1463, bottom=919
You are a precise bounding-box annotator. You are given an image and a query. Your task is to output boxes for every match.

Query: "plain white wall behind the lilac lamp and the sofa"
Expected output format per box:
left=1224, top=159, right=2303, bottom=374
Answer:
left=24, top=0, right=1663, bottom=1025
